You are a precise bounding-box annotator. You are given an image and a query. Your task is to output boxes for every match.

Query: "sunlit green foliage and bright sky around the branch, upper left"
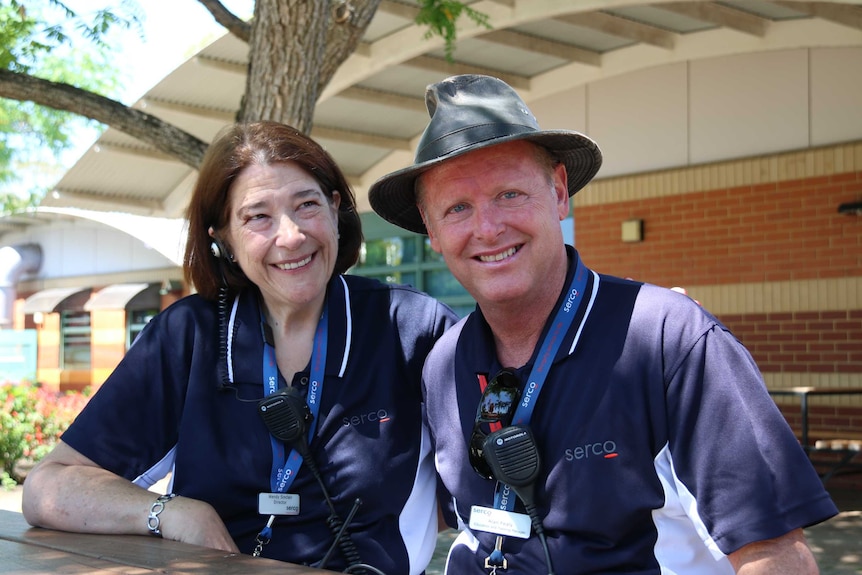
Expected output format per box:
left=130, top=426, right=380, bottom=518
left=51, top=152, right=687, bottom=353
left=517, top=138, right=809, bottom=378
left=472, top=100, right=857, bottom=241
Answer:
left=0, top=0, right=142, bottom=207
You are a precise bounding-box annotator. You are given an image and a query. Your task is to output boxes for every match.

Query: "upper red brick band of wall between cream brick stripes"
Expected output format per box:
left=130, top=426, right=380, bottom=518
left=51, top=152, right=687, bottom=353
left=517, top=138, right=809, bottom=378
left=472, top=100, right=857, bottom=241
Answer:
left=575, top=172, right=862, bottom=286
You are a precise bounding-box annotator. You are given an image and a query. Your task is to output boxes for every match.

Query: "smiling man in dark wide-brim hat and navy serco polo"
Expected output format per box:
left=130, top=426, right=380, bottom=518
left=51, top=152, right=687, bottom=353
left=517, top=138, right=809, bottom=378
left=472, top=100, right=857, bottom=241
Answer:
left=369, top=75, right=837, bottom=575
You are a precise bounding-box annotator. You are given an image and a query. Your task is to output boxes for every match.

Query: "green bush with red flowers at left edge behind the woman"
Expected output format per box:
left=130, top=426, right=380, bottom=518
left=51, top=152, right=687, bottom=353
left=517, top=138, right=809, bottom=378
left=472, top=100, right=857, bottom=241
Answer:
left=0, top=383, right=90, bottom=487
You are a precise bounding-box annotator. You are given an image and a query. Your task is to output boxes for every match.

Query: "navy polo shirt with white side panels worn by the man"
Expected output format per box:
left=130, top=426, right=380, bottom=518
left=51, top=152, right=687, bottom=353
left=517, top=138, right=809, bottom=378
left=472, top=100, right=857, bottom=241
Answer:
left=423, top=249, right=837, bottom=575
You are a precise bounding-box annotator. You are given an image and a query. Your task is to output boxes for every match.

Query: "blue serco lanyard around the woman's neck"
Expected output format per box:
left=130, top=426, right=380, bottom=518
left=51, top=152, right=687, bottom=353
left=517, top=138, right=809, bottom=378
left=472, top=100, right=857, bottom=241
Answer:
left=261, top=302, right=329, bottom=493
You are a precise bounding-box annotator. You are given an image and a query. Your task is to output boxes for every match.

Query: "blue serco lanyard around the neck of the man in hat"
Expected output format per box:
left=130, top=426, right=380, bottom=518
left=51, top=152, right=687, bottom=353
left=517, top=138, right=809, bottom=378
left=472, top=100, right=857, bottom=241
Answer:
left=494, top=256, right=590, bottom=511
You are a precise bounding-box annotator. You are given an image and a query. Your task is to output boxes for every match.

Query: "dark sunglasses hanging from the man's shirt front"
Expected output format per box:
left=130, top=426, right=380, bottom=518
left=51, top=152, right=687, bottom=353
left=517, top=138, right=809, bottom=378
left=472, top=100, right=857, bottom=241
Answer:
left=470, top=368, right=521, bottom=479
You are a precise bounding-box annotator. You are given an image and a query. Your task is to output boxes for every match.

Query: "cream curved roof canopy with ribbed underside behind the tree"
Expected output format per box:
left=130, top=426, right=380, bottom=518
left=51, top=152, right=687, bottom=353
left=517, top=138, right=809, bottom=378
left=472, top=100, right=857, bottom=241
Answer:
left=42, top=0, right=862, bottom=218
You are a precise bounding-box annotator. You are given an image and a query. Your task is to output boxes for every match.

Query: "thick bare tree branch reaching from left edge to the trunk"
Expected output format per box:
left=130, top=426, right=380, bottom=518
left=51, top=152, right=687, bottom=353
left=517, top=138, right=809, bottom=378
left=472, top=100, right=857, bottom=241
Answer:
left=0, top=69, right=208, bottom=169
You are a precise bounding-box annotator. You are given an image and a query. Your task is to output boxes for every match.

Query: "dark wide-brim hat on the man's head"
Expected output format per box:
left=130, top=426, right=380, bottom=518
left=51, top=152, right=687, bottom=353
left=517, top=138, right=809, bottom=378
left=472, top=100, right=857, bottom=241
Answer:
left=368, top=74, right=602, bottom=234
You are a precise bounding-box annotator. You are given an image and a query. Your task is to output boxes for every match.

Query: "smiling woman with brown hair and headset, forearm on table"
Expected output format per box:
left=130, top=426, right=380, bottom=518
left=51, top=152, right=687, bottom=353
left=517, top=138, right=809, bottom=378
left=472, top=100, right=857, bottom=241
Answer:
left=23, top=122, right=457, bottom=575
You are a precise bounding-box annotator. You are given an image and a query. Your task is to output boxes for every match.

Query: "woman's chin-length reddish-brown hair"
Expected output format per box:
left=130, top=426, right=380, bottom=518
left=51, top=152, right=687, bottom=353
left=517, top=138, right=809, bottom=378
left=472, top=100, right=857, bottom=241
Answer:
left=183, top=122, right=362, bottom=300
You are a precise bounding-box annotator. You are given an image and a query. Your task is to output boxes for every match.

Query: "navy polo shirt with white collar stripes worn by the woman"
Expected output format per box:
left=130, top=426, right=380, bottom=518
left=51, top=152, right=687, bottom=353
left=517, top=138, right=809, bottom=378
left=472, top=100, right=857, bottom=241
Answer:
left=63, top=276, right=457, bottom=574
